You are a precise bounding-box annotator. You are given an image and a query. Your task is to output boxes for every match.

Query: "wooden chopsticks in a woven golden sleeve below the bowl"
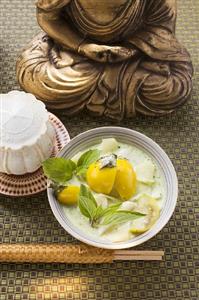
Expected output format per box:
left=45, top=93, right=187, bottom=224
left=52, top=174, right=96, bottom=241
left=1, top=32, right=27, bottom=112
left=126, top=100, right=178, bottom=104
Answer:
left=0, top=244, right=164, bottom=264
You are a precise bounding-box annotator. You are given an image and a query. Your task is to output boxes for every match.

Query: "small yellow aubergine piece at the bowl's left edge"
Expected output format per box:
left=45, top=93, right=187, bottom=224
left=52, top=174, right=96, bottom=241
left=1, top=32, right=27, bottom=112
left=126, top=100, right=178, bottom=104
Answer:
left=57, top=185, right=80, bottom=205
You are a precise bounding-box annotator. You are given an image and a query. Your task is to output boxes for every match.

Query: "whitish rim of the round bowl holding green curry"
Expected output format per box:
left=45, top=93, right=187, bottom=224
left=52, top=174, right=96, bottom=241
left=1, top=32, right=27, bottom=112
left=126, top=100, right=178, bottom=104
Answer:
left=47, top=126, right=178, bottom=250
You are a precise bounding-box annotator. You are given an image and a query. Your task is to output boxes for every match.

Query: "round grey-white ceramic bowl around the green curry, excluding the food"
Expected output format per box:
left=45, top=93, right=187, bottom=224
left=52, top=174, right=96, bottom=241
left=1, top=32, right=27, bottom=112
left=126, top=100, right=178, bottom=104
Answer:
left=48, top=127, right=178, bottom=249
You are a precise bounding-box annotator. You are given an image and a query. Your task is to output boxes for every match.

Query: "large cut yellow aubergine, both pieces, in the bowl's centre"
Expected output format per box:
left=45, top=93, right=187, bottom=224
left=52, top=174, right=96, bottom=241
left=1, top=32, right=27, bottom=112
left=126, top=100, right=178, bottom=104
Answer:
left=87, top=159, right=136, bottom=200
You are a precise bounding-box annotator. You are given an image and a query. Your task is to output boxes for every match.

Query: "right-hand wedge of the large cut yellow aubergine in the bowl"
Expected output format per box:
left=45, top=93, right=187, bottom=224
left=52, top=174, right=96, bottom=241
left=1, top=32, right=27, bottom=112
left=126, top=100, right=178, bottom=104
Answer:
left=114, top=159, right=136, bottom=200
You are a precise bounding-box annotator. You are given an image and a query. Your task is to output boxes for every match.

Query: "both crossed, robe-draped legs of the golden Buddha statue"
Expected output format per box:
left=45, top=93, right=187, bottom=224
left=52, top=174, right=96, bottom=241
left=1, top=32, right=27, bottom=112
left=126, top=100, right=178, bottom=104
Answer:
left=17, top=33, right=192, bottom=120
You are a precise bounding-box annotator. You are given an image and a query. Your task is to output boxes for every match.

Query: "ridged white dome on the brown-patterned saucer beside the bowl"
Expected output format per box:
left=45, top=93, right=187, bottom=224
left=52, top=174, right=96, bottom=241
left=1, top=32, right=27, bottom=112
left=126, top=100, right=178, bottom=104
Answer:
left=0, top=91, right=55, bottom=175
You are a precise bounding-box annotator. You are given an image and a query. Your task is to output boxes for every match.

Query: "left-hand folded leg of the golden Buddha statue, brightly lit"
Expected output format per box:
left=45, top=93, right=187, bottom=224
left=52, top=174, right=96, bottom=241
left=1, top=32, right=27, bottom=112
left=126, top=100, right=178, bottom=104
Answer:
left=17, top=33, right=102, bottom=115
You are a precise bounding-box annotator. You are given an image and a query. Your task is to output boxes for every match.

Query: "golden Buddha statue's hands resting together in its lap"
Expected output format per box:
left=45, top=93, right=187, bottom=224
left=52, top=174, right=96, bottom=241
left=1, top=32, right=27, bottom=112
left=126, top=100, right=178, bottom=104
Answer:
left=78, top=43, right=138, bottom=63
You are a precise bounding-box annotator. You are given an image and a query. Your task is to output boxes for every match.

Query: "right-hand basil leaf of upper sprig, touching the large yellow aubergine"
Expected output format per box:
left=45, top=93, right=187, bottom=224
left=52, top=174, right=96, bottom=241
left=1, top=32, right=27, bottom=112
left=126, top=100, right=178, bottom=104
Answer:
left=77, top=149, right=100, bottom=175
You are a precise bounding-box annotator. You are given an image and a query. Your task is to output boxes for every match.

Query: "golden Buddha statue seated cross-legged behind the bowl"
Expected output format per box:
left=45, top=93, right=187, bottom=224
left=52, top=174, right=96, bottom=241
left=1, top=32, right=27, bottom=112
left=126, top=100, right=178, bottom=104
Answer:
left=17, top=0, right=193, bottom=120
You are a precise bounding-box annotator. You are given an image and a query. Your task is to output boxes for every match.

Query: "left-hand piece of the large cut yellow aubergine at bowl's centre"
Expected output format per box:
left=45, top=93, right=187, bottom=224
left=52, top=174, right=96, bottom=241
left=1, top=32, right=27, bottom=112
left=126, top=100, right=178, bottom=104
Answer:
left=86, top=162, right=117, bottom=195
